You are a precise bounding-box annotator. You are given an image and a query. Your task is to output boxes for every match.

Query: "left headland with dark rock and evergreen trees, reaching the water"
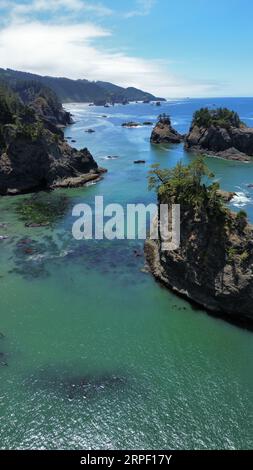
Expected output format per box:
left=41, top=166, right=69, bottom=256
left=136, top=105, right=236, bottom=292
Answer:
left=0, top=85, right=104, bottom=195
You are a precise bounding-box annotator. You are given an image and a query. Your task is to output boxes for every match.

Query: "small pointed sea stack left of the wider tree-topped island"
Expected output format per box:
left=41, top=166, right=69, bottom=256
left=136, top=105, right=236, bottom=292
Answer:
left=150, top=114, right=184, bottom=144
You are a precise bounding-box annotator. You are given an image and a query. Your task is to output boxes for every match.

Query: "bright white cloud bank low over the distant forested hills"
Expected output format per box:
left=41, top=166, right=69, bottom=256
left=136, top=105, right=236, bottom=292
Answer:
left=0, top=21, right=223, bottom=97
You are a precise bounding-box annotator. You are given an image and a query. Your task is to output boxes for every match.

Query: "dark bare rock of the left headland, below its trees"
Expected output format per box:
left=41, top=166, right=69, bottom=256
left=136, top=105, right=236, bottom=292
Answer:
left=0, top=128, right=105, bottom=195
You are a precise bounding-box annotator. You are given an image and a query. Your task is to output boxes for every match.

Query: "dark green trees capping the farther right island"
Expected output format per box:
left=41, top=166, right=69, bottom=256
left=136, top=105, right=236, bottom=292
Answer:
left=192, top=108, right=243, bottom=128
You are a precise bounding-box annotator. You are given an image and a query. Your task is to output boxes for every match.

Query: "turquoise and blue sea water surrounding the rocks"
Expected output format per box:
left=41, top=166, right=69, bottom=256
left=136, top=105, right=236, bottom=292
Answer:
left=0, top=99, right=253, bottom=449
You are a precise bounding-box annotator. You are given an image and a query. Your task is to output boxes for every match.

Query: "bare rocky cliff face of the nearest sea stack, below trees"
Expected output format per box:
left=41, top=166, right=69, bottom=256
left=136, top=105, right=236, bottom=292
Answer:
left=145, top=160, right=253, bottom=322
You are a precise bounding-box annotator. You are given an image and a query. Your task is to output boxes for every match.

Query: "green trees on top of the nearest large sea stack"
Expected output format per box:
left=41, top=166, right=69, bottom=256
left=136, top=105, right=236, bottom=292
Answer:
left=149, top=156, right=226, bottom=214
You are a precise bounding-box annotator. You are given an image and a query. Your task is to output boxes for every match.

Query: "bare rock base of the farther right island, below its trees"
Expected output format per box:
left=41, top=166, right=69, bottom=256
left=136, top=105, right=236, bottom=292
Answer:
left=185, top=110, right=253, bottom=161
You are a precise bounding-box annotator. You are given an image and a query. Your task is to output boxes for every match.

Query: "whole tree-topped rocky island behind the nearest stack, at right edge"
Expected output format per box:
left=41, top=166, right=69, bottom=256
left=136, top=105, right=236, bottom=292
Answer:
left=185, top=108, right=253, bottom=161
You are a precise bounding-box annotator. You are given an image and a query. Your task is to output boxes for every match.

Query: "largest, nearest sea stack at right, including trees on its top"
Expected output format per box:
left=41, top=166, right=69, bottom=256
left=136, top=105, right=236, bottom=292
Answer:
left=145, top=158, right=253, bottom=324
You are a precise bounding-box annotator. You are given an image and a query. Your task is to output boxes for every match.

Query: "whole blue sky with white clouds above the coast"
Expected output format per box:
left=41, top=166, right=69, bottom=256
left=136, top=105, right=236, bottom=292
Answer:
left=0, top=0, right=253, bottom=98
